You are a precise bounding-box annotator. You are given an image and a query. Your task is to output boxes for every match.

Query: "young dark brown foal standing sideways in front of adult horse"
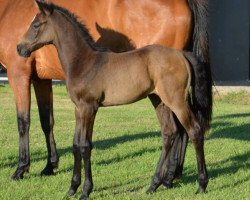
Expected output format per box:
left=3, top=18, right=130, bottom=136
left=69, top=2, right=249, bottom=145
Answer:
left=17, top=1, right=212, bottom=199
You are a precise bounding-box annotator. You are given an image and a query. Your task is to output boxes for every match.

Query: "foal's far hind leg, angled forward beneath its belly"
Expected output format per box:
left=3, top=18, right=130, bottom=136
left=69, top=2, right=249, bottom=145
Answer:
left=147, top=94, right=181, bottom=193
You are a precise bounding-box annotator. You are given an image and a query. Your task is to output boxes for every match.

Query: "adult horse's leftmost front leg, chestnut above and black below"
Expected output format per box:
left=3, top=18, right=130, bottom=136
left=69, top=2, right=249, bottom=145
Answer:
left=7, top=61, right=30, bottom=180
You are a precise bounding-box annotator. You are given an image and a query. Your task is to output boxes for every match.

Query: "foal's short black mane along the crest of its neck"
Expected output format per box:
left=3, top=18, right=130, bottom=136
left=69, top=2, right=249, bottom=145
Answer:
left=48, top=3, right=107, bottom=51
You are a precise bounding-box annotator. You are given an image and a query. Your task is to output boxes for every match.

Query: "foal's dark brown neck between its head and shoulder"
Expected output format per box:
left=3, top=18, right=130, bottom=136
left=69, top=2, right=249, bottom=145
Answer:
left=53, top=11, right=96, bottom=78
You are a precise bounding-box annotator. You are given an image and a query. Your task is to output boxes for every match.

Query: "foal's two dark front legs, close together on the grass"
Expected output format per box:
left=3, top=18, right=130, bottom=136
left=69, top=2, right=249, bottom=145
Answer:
left=68, top=103, right=97, bottom=199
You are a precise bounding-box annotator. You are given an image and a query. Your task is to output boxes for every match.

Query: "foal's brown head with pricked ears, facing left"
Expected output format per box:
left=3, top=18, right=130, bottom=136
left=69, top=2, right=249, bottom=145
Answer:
left=17, top=0, right=55, bottom=57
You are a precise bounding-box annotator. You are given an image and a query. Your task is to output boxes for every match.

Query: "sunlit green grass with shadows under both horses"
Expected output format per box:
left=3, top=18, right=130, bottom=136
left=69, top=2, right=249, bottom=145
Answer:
left=0, top=85, right=250, bottom=200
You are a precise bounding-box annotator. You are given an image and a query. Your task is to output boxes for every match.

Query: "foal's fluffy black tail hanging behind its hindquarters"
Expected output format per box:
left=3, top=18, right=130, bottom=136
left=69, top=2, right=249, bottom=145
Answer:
left=183, top=52, right=213, bottom=131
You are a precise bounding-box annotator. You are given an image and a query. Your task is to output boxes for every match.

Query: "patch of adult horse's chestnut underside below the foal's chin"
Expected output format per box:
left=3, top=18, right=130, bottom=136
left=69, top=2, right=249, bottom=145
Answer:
left=35, top=45, right=65, bottom=80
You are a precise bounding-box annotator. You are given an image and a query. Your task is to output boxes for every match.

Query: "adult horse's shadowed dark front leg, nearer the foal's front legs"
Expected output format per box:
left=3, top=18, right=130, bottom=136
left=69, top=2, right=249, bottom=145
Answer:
left=33, top=78, right=59, bottom=175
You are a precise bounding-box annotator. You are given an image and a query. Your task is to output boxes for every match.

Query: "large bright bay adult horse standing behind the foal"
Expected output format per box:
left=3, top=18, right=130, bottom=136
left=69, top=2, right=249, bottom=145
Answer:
left=0, top=0, right=208, bottom=191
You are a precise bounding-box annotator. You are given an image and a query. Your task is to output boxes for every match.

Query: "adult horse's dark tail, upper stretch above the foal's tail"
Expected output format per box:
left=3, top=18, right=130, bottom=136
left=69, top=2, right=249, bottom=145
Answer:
left=188, top=0, right=210, bottom=63
